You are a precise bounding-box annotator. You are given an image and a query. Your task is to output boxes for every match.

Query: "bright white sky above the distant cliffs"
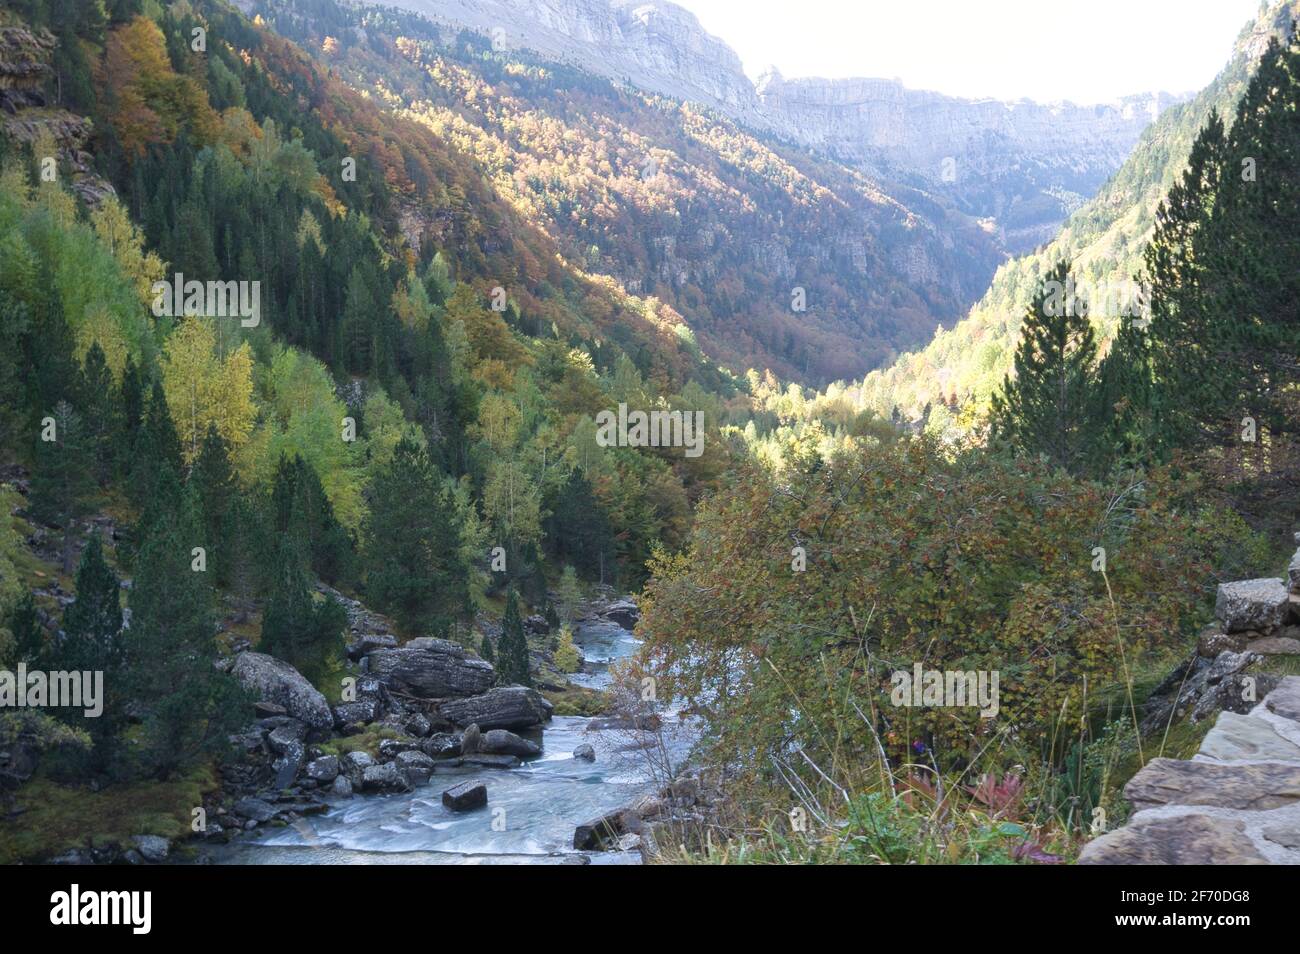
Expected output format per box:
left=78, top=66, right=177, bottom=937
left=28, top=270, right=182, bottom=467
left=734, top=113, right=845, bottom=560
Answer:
left=673, top=0, right=1260, bottom=104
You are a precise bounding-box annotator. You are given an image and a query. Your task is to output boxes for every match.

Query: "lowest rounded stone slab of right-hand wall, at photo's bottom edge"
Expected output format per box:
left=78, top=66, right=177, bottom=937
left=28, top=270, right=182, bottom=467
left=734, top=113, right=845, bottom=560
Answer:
left=1079, top=816, right=1269, bottom=864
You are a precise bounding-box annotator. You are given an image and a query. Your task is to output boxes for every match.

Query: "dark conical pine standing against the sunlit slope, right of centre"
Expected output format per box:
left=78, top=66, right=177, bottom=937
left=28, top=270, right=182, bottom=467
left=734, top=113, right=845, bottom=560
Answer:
left=992, top=261, right=1097, bottom=473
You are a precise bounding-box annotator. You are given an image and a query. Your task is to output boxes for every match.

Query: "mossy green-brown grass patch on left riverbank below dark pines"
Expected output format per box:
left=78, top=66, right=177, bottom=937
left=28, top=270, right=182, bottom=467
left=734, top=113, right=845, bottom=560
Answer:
left=0, top=766, right=217, bottom=864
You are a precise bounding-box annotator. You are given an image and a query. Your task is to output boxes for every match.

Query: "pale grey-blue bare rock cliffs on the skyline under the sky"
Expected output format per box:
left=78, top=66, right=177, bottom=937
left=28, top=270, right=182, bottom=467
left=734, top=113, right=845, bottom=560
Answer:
left=366, top=0, right=1178, bottom=253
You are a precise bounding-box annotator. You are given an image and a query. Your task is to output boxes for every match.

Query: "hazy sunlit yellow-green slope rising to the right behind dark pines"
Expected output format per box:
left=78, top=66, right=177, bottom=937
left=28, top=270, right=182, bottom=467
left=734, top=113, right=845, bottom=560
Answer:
left=859, top=0, right=1300, bottom=426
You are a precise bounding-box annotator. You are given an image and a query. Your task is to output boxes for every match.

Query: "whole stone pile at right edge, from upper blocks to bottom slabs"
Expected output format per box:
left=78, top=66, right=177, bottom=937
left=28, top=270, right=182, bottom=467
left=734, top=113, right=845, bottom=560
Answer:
left=1079, top=539, right=1300, bottom=864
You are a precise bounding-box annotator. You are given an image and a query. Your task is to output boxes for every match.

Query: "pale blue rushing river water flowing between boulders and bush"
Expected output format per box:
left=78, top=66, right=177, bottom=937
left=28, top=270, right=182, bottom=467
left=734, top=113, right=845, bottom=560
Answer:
left=202, top=621, right=689, bottom=864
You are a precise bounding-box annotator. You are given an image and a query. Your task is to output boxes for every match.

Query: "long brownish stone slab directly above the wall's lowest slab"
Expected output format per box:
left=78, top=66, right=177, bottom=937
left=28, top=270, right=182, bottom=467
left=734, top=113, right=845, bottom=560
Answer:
left=1125, top=759, right=1300, bottom=811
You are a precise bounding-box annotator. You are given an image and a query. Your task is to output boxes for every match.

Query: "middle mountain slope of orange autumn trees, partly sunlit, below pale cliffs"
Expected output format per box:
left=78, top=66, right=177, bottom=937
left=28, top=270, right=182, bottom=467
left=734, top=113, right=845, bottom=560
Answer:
left=250, top=0, right=1001, bottom=382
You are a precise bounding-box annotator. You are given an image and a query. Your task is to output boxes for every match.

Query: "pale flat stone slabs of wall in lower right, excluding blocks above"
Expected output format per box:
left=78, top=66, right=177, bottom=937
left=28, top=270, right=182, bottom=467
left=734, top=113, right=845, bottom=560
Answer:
left=1079, top=676, right=1300, bottom=864
